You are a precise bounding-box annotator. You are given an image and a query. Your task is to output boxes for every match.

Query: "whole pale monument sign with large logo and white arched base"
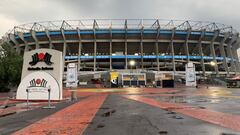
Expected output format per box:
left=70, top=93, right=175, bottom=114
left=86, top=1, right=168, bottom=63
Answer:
left=16, top=49, right=63, bottom=100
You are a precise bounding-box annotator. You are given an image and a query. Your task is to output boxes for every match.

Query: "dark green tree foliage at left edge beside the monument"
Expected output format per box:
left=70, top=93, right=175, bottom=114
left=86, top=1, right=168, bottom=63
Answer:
left=0, top=43, right=23, bottom=92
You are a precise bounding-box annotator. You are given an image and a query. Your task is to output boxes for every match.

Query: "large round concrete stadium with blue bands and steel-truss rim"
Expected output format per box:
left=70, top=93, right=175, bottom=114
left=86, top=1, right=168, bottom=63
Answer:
left=3, top=19, right=240, bottom=86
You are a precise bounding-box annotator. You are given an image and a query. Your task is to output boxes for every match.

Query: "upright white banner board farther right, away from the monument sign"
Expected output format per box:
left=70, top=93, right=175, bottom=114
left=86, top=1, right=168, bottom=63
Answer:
left=185, top=63, right=197, bottom=86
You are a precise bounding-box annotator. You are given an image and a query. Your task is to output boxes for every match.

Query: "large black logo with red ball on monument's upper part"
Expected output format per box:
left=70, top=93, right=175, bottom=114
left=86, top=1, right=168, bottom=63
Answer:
left=29, top=53, right=53, bottom=66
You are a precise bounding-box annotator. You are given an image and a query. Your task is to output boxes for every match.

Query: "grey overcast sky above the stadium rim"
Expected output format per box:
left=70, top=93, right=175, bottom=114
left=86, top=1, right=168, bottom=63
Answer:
left=0, top=0, right=240, bottom=37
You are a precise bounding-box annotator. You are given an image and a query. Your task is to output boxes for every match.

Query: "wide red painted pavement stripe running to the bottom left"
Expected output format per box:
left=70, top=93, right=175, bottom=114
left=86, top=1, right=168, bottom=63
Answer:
left=13, top=94, right=107, bottom=135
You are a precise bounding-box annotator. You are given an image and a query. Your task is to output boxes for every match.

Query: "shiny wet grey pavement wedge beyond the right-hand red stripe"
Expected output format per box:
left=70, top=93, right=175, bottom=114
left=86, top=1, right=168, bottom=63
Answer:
left=143, top=87, right=240, bottom=115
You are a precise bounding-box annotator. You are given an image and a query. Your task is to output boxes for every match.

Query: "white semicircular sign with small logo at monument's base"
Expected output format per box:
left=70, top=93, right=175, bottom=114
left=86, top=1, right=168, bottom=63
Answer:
left=16, top=71, right=61, bottom=100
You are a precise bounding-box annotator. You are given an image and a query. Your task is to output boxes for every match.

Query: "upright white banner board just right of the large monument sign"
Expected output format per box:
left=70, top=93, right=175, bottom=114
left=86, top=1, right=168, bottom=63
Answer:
left=66, top=63, right=78, bottom=87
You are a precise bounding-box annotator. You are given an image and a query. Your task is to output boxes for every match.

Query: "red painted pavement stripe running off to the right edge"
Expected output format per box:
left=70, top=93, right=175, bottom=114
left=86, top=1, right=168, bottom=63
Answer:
left=124, top=96, right=240, bottom=131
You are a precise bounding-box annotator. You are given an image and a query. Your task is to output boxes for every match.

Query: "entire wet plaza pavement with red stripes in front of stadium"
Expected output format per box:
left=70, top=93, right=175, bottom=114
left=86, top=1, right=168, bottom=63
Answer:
left=0, top=86, right=240, bottom=135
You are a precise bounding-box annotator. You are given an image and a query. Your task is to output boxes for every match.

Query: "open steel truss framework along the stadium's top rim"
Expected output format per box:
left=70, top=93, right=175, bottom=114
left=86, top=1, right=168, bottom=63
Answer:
left=8, top=19, right=238, bottom=34
